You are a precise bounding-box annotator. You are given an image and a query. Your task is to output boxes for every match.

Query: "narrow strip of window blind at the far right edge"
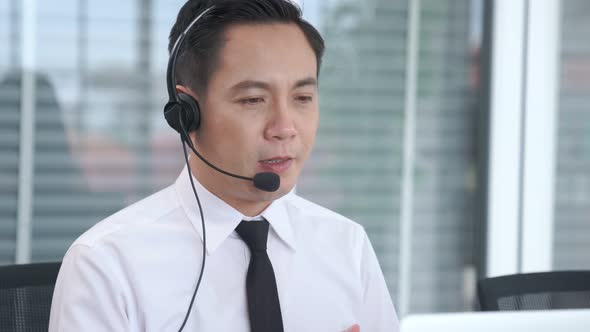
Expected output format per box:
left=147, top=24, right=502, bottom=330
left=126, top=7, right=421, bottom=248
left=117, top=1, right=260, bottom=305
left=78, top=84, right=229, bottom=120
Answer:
left=553, top=0, right=590, bottom=270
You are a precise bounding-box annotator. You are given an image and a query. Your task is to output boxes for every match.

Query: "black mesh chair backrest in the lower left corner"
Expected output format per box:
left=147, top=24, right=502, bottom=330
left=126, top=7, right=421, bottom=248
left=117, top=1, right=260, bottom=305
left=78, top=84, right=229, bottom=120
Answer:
left=0, top=263, right=61, bottom=332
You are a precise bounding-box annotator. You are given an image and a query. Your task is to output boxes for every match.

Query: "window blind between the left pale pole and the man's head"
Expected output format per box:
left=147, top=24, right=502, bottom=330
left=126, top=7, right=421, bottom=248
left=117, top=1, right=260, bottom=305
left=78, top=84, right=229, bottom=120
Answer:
left=26, top=0, right=183, bottom=261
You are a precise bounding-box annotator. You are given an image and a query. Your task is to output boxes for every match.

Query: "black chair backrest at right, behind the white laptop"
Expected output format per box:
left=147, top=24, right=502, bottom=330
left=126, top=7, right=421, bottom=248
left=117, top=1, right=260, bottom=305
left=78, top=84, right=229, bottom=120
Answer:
left=477, top=271, right=590, bottom=311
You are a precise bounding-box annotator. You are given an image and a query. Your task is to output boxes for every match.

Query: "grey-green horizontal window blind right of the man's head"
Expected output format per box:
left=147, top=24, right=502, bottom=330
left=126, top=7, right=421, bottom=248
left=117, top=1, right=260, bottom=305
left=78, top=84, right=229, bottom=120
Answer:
left=298, top=0, right=481, bottom=312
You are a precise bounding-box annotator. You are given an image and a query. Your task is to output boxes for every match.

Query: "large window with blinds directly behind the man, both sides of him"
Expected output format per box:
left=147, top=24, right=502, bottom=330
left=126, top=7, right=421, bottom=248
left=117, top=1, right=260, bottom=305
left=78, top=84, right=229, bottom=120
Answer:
left=0, top=0, right=482, bottom=312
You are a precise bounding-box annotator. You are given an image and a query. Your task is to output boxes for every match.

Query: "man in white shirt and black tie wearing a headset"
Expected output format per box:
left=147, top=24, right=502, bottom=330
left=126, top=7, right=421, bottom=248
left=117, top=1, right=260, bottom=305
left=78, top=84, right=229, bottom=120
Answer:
left=50, top=0, right=398, bottom=332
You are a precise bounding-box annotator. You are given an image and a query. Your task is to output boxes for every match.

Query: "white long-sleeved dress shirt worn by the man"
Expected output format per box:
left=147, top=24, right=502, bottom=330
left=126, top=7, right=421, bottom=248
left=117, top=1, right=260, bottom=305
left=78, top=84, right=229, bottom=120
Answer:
left=49, top=167, right=399, bottom=332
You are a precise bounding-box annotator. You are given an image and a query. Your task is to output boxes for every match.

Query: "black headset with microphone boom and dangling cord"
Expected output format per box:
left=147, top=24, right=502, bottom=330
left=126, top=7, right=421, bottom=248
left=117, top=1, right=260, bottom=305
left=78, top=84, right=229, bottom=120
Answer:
left=164, top=6, right=281, bottom=332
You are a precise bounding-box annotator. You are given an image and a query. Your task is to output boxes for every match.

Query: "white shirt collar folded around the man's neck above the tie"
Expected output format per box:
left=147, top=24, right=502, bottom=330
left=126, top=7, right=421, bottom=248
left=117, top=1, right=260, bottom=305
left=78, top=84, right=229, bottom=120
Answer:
left=174, top=165, right=296, bottom=255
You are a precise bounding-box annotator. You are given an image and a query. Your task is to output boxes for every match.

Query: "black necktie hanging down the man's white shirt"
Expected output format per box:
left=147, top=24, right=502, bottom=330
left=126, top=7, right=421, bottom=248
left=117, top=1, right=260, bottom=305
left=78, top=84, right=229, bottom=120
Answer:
left=236, top=220, right=283, bottom=332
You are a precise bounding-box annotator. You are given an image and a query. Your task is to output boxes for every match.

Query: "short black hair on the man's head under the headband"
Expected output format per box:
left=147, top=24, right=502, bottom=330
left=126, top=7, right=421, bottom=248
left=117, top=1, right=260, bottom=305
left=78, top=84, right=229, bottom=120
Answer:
left=168, top=0, right=324, bottom=95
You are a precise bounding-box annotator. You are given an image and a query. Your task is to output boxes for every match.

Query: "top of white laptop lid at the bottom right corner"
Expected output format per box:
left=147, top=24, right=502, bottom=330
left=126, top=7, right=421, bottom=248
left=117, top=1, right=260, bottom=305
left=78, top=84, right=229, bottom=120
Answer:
left=401, top=309, right=590, bottom=332
